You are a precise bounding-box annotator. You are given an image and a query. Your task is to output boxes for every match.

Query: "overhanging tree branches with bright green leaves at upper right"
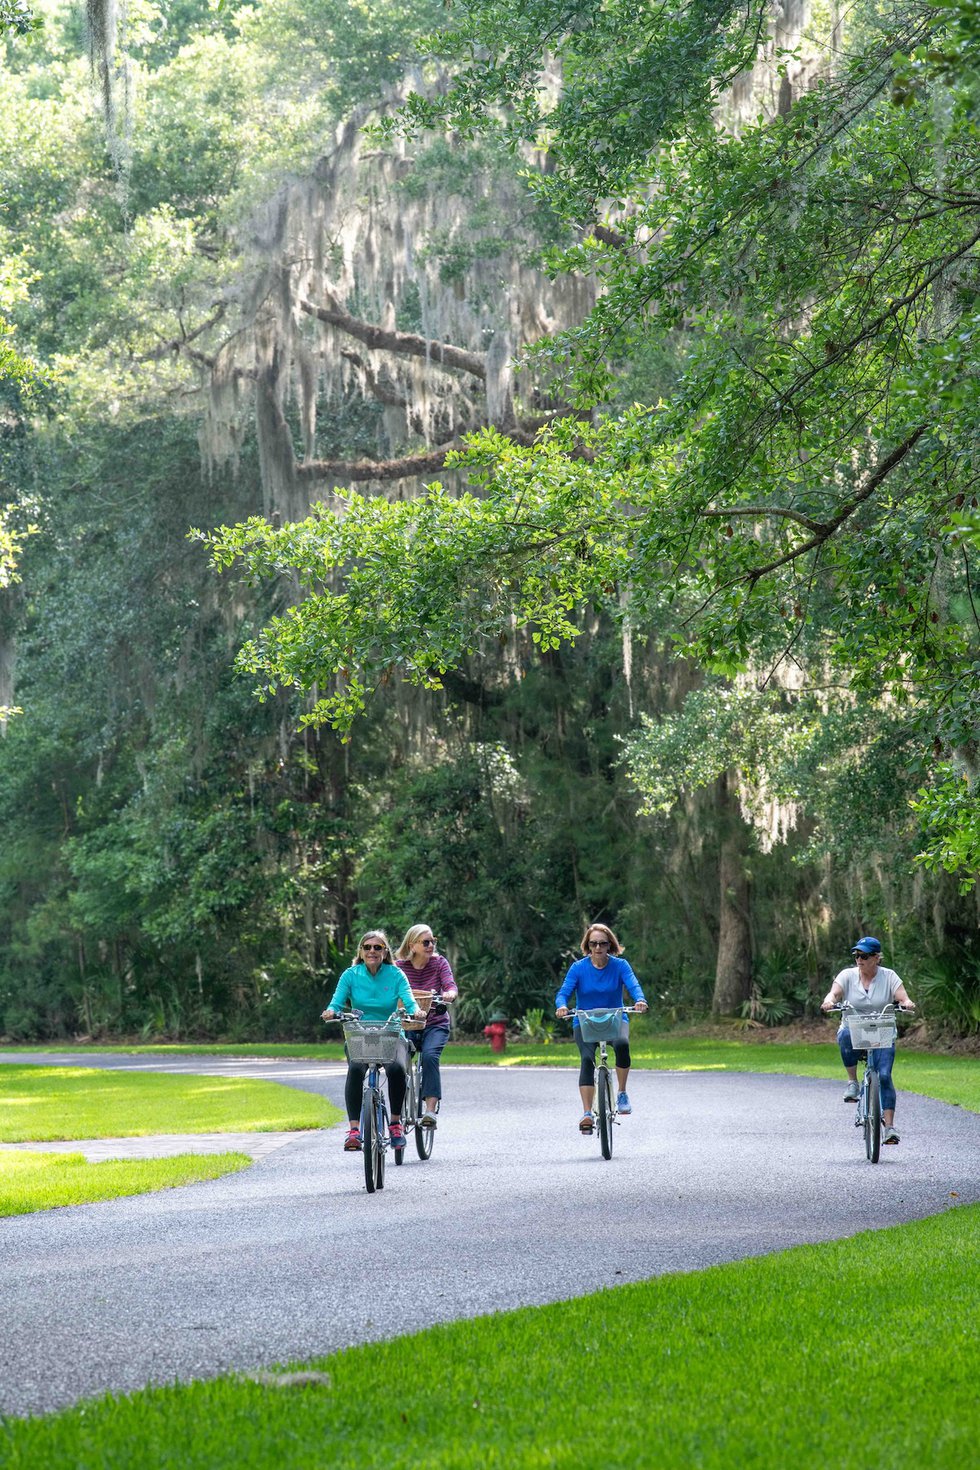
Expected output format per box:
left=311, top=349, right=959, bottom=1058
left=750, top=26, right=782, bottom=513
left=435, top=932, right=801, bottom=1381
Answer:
left=205, top=0, right=980, bottom=911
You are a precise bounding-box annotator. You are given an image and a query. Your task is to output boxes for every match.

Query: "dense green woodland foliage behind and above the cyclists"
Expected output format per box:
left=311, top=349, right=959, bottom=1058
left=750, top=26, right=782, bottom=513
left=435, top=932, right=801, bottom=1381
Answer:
left=0, top=0, right=980, bottom=1038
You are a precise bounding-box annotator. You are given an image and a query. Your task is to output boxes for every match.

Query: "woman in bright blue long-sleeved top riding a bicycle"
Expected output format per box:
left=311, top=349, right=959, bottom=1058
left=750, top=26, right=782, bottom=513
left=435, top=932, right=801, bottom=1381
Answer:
left=555, top=923, right=646, bottom=1133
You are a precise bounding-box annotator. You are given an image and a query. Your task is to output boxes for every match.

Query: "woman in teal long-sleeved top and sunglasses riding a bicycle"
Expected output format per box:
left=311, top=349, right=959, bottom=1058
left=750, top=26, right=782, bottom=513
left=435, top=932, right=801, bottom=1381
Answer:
left=323, top=929, right=419, bottom=1152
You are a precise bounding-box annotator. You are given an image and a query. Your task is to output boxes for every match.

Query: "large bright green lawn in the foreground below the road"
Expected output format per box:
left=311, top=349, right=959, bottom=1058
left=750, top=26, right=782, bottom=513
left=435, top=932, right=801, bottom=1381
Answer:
left=0, top=1207, right=980, bottom=1470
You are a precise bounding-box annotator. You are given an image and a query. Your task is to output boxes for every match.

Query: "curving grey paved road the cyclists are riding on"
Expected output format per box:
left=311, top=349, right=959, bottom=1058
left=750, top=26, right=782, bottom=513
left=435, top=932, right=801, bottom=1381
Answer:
left=0, top=1057, right=980, bottom=1414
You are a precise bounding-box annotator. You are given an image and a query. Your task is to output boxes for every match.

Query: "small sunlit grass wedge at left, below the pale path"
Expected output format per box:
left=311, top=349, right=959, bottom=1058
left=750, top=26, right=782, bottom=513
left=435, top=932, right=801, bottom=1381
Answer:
left=0, top=1148, right=251, bottom=1217
